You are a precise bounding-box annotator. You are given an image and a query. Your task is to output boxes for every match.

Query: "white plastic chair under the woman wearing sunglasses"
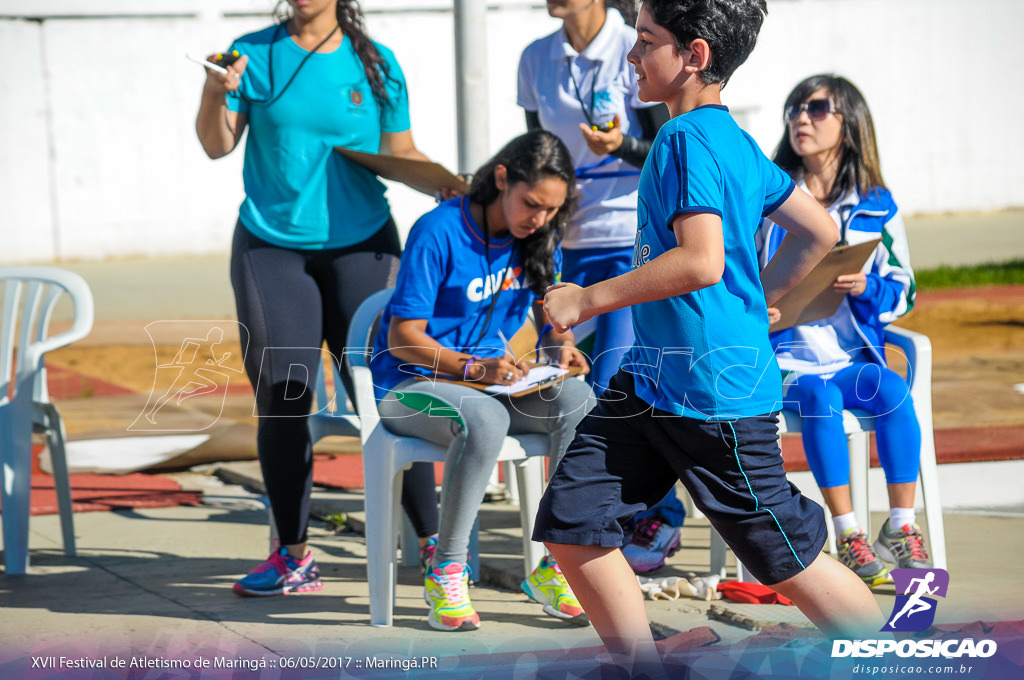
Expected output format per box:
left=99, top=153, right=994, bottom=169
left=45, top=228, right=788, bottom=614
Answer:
left=711, top=326, right=946, bottom=581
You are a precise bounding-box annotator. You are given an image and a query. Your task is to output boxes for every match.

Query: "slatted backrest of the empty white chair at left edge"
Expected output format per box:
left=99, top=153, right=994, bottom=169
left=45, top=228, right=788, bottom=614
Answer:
left=0, top=266, right=93, bottom=403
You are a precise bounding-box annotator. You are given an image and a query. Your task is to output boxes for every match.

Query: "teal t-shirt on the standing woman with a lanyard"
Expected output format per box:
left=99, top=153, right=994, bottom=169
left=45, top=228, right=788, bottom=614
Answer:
left=227, top=26, right=410, bottom=250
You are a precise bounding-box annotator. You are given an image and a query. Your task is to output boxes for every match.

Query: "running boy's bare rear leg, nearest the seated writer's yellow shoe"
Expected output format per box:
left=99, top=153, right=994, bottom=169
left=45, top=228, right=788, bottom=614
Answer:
left=545, top=543, right=659, bottom=668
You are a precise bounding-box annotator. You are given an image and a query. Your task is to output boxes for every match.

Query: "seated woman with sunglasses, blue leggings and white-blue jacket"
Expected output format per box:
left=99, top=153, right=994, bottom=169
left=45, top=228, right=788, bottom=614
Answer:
left=758, top=75, right=930, bottom=587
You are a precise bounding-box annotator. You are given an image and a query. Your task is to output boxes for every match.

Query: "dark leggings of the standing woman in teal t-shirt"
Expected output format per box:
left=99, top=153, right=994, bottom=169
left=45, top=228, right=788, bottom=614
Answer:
left=231, top=219, right=433, bottom=545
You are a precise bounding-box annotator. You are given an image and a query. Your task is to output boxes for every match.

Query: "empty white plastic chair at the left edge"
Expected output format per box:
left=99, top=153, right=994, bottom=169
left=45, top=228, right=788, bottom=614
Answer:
left=0, top=266, right=93, bottom=573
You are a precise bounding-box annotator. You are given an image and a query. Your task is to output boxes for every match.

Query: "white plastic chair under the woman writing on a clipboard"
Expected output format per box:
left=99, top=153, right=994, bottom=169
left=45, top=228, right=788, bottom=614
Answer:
left=346, top=289, right=549, bottom=626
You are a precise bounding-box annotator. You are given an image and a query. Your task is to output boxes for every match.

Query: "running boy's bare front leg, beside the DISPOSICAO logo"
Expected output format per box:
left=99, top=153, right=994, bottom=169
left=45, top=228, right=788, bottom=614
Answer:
left=770, top=553, right=885, bottom=639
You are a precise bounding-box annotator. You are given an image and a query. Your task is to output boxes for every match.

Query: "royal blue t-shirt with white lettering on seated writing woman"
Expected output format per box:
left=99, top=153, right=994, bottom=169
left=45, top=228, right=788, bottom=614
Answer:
left=370, top=197, right=562, bottom=400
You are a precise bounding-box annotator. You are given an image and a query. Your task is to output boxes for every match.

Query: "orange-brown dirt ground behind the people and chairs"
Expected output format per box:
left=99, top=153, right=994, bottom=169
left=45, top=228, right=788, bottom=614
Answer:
left=47, top=286, right=1024, bottom=428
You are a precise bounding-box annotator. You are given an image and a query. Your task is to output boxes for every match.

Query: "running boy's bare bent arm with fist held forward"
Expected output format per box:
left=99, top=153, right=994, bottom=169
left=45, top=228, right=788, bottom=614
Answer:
left=544, top=213, right=725, bottom=331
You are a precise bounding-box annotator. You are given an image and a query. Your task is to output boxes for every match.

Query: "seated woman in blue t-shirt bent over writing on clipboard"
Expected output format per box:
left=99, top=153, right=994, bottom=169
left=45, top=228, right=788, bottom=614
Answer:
left=370, top=130, right=593, bottom=631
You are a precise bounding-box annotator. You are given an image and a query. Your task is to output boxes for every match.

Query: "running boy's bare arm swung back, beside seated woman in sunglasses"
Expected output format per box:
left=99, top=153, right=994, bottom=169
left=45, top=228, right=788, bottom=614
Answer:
left=761, top=189, right=839, bottom=306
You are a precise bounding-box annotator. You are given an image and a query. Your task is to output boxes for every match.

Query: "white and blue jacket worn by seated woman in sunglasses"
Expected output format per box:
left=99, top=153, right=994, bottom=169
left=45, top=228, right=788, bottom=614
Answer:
left=756, top=180, right=916, bottom=374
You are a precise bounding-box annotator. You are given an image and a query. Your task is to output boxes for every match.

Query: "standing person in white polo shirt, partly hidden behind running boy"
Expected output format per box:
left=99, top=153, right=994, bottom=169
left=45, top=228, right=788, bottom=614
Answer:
left=518, top=0, right=686, bottom=573
